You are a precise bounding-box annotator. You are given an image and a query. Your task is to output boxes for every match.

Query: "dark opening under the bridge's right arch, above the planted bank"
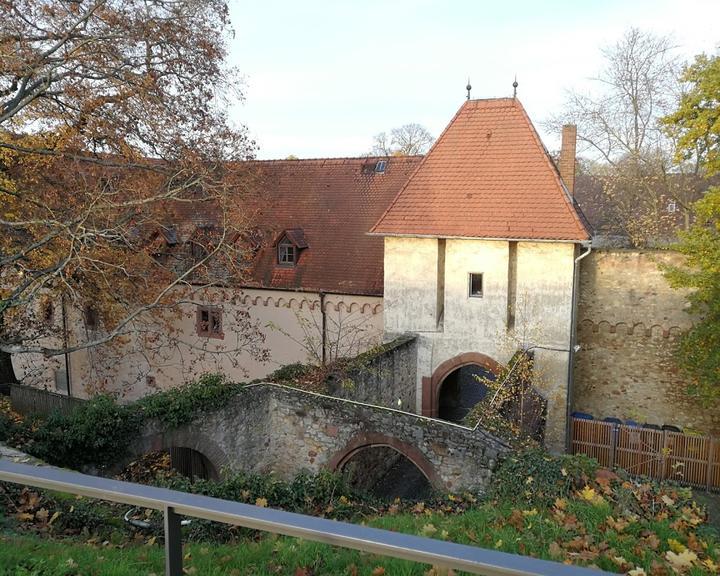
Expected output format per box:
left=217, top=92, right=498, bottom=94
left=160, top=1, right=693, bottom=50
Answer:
left=339, top=446, right=433, bottom=500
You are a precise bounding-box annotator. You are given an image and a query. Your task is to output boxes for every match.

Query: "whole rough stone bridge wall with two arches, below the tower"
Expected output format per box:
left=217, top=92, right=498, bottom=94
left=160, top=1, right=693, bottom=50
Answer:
left=131, top=383, right=509, bottom=491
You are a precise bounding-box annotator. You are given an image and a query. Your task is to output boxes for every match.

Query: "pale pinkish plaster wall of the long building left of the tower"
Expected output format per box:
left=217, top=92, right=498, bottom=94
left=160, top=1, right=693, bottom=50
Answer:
left=13, top=288, right=382, bottom=400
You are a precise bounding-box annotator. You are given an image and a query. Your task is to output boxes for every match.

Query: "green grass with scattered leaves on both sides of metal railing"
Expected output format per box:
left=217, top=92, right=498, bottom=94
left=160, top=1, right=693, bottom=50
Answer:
left=0, top=500, right=718, bottom=576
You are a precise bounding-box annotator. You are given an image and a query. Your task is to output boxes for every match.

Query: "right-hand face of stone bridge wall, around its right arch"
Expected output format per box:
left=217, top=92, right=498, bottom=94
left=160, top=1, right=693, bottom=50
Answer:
left=262, top=389, right=507, bottom=490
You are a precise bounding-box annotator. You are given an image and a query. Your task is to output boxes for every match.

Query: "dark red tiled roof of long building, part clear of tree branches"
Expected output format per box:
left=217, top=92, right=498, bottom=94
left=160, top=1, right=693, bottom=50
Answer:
left=245, top=156, right=422, bottom=296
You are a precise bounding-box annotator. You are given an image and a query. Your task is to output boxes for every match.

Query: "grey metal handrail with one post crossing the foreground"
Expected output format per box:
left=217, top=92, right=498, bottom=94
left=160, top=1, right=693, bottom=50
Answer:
left=0, top=459, right=607, bottom=576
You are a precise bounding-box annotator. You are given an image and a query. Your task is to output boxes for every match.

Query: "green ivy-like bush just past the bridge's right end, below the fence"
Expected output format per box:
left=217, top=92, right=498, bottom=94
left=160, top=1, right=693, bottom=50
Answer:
left=488, top=448, right=598, bottom=507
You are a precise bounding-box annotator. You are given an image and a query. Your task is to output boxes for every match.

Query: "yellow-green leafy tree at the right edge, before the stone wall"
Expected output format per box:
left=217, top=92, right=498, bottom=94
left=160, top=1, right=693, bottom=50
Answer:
left=664, top=55, right=720, bottom=400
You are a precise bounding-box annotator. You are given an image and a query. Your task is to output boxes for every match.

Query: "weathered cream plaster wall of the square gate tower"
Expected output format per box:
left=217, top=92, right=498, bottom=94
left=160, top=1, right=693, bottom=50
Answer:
left=385, top=238, right=575, bottom=451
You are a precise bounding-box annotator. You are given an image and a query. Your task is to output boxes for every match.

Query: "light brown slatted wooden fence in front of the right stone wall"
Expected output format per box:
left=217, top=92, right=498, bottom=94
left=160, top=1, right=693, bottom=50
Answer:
left=571, top=418, right=720, bottom=490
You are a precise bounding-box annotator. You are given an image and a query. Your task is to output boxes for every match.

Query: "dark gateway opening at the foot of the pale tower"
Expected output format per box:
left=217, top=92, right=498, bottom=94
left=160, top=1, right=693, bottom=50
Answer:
left=438, top=364, right=496, bottom=423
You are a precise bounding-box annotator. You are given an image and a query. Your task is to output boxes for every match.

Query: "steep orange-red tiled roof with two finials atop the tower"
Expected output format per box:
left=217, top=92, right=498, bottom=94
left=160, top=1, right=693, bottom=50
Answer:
left=370, top=98, right=590, bottom=242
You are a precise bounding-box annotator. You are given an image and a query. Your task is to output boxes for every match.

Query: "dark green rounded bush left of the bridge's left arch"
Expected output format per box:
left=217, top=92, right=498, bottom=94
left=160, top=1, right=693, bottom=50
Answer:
left=28, top=395, right=142, bottom=469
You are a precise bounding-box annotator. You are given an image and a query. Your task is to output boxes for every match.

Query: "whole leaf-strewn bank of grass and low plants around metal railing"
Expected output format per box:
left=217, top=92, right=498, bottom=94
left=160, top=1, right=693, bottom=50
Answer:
left=0, top=450, right=720, bottom=576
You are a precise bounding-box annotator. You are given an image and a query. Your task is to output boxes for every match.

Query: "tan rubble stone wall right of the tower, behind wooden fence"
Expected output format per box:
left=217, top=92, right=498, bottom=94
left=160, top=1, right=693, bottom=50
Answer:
left=572, top=250, right=720, bottom=435
